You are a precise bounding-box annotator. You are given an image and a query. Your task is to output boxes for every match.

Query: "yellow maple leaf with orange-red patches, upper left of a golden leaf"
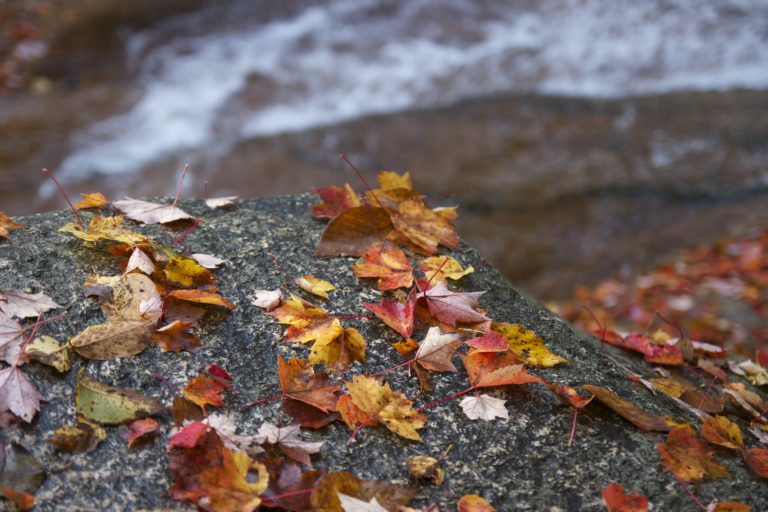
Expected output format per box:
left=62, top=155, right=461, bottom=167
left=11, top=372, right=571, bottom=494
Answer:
left=268, top=294, right=344, bottom=345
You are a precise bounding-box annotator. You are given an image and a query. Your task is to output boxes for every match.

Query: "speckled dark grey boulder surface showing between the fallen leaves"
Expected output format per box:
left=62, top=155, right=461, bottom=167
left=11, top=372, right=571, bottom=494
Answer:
left=0, top=195, right=768, bottom=511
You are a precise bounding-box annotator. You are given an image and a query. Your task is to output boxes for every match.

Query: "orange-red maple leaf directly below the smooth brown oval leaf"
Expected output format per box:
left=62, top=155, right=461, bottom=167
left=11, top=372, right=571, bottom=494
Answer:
left=352, top=242, right=413, bottom=291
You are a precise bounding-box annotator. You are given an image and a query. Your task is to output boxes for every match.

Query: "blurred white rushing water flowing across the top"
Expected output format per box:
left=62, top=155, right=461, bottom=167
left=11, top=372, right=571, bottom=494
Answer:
left=51, top=0, right=768, bottom=187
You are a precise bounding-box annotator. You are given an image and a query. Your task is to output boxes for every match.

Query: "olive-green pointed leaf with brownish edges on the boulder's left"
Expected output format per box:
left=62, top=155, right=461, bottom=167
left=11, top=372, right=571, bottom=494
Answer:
left=75, top=371, right=165, bottom=425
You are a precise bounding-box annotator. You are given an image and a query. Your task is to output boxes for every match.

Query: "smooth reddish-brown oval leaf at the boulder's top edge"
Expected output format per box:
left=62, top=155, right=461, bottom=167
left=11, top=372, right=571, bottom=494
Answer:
left=317, top=206, right=392, bottom=256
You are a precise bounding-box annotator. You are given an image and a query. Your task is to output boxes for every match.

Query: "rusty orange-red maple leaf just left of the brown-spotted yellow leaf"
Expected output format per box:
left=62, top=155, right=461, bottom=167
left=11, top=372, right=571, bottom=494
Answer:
left=277, top=355, right=341, bottom=412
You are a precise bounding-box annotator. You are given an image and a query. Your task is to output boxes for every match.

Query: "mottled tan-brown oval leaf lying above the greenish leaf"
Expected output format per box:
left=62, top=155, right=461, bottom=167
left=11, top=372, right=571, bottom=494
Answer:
left=69, top=320, right=155, bottom=361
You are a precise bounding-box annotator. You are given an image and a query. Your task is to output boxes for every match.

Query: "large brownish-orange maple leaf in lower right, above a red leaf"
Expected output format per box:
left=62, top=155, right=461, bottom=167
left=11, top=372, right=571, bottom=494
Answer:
left=656, top=425, right=730, bottom=482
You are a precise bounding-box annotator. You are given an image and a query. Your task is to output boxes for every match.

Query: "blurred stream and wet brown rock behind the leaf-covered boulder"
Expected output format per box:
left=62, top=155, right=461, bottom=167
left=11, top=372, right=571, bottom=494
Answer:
left=0, top=0, right=768, bottom=299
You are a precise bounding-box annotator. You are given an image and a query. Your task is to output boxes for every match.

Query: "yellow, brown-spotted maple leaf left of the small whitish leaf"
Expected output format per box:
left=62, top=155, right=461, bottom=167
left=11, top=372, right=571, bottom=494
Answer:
left=346, top=375, right=427, bottom=441
